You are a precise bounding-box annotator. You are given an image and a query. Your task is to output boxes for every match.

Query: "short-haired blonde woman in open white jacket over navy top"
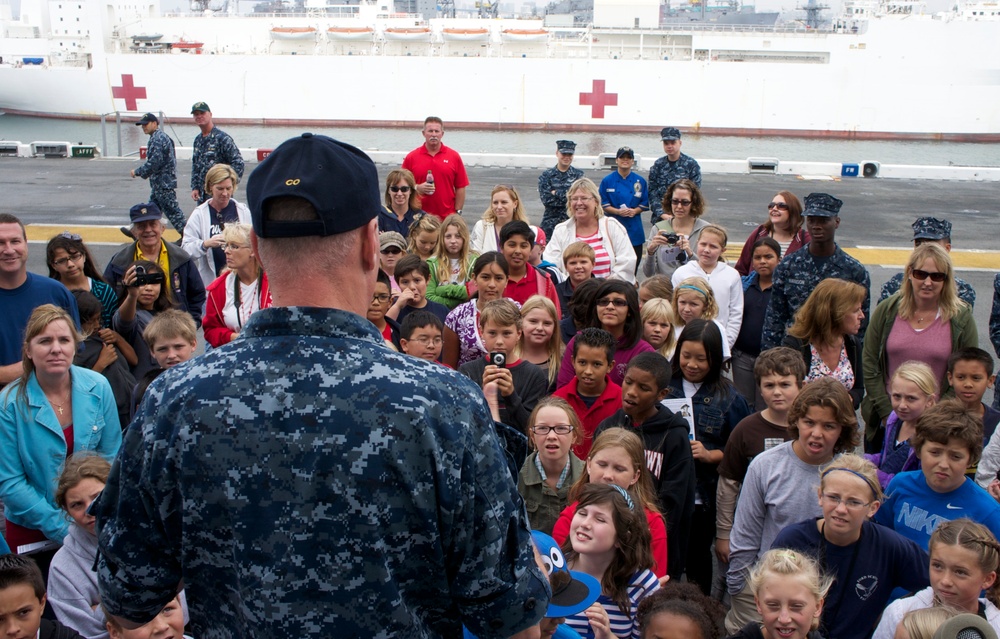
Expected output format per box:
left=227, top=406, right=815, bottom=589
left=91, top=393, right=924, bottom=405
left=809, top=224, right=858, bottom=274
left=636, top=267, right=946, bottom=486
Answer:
left=181, top=164, right=250, bottom=285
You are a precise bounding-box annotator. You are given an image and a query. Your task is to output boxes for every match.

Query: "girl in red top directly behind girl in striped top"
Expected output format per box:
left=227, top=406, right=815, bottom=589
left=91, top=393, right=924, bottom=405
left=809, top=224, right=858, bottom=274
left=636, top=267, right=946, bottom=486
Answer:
left=552, top=428, right=667, bottom=577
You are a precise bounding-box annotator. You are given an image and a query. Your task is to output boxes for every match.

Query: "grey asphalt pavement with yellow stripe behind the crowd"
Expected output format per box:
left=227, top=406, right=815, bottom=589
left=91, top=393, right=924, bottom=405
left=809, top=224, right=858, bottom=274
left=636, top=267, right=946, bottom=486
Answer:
left=0, top=158, right=1000, bottom=400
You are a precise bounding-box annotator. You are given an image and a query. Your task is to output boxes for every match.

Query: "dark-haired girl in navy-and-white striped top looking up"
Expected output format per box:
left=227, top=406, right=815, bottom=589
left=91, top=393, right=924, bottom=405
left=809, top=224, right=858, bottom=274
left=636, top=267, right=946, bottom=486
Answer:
left=562, top=483, right=660, bottom=639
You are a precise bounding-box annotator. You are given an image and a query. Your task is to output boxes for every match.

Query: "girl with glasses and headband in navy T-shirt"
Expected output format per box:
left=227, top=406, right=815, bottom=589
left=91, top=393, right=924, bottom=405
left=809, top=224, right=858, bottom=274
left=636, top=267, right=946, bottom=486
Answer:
left=771, top=454, right=930, bottom=639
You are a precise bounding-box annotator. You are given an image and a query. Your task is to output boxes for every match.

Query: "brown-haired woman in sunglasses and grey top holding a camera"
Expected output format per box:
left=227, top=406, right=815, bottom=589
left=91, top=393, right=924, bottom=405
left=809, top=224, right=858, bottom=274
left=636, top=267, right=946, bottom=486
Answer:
left=642, top=178, right=709, bottom=277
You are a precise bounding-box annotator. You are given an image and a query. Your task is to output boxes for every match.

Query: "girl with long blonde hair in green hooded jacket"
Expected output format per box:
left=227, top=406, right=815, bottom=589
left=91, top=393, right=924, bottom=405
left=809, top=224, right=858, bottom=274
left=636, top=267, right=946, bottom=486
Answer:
left=427, top=213, right=479, bottom=309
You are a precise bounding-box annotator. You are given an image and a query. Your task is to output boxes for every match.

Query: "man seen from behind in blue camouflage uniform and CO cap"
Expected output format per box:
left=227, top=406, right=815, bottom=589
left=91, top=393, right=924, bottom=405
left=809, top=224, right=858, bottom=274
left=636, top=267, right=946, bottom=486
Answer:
left=94, top=133, right=550, bottom=639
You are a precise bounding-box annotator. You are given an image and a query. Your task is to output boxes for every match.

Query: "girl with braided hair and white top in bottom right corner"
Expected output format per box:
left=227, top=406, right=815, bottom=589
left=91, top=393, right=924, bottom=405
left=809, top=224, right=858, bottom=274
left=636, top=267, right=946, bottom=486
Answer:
left=872, top=517, right=1000, bottom=639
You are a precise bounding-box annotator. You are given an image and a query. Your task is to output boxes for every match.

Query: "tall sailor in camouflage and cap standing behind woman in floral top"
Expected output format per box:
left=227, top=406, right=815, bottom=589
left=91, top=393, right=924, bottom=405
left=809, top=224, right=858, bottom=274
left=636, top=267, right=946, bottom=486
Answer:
left=760, top=193, right=871, bottom=351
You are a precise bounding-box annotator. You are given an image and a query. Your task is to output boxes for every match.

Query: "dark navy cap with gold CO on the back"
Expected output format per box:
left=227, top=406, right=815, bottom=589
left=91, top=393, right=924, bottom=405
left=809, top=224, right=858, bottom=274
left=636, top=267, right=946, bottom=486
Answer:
left=247, top=133, right=382, bottom=238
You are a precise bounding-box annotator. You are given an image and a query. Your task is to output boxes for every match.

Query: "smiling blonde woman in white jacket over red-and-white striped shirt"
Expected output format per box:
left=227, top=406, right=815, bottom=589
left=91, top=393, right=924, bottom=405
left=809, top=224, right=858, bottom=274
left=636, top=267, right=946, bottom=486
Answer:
left=542, top=178, right=635, bottom=282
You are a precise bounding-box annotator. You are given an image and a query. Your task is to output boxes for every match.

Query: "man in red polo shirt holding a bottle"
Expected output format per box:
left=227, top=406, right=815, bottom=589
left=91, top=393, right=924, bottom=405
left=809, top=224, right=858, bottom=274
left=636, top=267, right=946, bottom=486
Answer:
left=403, top=116, right=469, bottom=220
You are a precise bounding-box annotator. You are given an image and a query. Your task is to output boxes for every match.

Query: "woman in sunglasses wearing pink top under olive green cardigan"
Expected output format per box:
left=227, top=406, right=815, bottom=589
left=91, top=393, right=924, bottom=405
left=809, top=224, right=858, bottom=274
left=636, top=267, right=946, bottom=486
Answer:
left=861, top=243, right=979, bottom=452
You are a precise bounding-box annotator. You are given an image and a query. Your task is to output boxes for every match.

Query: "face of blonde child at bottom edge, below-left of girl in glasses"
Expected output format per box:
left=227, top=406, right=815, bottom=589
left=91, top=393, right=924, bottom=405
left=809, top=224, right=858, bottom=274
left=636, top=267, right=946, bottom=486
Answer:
left=754, top=575, right=823, bottom=639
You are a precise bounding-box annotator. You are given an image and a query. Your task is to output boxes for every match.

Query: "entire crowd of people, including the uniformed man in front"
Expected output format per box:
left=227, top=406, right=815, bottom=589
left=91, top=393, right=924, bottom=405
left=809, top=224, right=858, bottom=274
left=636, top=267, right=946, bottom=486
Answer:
left=0, top=115, right=1000, bottom=639
